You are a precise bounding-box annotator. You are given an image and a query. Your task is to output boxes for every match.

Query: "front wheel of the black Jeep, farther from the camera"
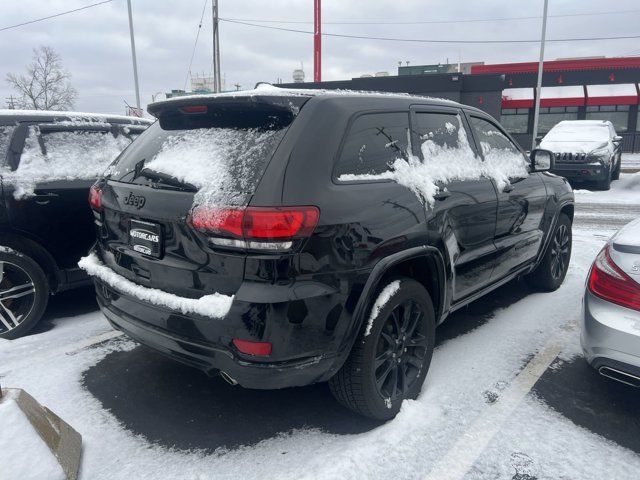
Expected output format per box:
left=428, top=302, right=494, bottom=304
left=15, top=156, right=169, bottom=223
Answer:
left=526, top=213, right=571, bottom=292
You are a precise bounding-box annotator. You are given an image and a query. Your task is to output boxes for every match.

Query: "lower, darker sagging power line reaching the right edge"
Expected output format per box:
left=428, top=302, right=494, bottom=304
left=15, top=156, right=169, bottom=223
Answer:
left=220, top=18, right=640, bottom=45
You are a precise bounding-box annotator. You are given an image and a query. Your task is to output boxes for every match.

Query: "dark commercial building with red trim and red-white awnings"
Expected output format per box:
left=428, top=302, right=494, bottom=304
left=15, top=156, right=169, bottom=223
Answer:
left=282, top=57, right=640, bottom=152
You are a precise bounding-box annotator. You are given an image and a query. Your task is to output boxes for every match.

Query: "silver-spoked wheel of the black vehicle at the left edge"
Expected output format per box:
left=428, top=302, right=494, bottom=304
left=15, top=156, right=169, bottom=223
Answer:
left=0, top=247, right=49, bottom=340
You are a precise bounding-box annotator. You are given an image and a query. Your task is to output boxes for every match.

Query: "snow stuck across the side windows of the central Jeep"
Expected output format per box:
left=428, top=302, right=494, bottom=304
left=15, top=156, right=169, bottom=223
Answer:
left=338, top=116, right=528, bottom=206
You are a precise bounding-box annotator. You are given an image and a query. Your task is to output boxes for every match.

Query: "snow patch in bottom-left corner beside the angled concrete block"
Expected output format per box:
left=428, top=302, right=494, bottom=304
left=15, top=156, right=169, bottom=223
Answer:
left=0, top=392, right=66, bottom=480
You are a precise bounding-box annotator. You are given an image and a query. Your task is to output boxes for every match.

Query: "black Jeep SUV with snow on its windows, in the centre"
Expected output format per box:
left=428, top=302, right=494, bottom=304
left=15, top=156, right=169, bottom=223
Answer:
left=86, top=87, right=574, bottom=419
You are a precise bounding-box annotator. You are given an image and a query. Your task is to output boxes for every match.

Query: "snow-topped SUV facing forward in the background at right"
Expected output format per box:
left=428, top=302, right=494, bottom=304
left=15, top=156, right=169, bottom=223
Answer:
left=540, top=120, right=622, bottom=190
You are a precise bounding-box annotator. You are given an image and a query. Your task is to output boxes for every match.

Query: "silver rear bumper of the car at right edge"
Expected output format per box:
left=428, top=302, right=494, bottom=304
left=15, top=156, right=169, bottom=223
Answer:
left=580, top=290, right=640, bottom=377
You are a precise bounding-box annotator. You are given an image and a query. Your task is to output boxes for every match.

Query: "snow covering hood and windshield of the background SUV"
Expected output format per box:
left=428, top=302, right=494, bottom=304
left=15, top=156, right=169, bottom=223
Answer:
left=540, top=120, right=612, bottom=153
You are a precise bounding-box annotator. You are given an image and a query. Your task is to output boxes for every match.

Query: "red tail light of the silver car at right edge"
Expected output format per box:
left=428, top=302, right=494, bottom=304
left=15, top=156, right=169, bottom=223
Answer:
left=588, top=245, right=640, bottom=310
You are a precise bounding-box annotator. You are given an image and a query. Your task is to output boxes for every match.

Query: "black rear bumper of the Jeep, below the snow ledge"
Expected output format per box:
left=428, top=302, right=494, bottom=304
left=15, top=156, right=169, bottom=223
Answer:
left=94, top=279, right=339, bottom=389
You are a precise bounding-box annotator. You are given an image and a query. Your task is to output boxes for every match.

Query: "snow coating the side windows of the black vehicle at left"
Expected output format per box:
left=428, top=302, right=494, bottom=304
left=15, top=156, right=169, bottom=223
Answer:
left=0, top=126, right=131, bottom=199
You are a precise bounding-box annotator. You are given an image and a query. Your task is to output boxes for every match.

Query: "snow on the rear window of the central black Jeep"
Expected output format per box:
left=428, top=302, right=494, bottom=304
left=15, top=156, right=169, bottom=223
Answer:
left=145, top=128, right=286, bottom=206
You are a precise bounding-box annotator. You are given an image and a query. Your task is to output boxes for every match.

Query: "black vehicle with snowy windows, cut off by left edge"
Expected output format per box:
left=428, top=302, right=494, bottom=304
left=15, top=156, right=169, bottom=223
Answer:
left=0, top=110, right=151, bottom=339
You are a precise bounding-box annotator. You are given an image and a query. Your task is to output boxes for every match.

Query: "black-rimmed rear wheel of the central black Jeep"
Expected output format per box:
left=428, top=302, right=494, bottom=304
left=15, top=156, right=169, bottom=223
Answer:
left=329, top=277, right=436, bottom=420
